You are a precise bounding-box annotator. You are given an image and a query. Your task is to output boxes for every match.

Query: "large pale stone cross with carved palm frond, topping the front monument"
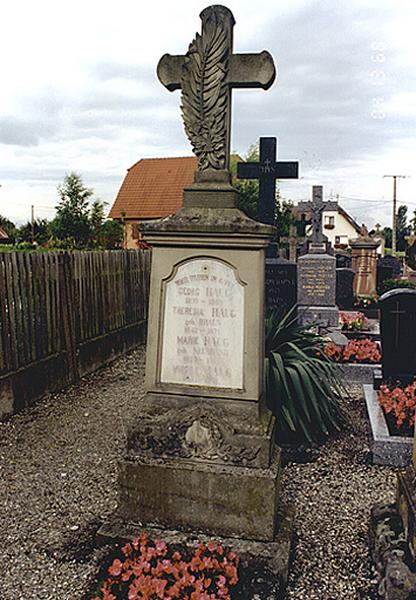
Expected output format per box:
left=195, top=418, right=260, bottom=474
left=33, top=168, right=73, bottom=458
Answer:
left=157, top=5, right=276, bottom=173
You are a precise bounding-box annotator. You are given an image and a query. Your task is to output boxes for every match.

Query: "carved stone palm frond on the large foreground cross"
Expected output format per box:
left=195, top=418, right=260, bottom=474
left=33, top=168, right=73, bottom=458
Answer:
left=181, top=12, right=229, bottom=170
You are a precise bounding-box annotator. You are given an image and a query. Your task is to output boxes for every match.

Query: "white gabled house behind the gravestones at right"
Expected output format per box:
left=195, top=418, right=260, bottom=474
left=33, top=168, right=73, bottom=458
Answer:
left=295, top=200, right=361, bottom=250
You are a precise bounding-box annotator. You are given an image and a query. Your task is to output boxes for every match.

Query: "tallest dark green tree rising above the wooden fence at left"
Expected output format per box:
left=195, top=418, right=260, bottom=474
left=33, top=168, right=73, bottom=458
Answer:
left=52, top=172, right=94, bottom=248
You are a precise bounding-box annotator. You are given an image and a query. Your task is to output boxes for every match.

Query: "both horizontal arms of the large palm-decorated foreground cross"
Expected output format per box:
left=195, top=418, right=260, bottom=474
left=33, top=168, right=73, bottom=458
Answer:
left=157, top=50, right=276, bottom=92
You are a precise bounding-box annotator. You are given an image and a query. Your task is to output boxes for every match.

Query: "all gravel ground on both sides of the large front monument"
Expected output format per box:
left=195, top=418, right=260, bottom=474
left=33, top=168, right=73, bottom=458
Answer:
left=0, top=349, right=395, bottom=600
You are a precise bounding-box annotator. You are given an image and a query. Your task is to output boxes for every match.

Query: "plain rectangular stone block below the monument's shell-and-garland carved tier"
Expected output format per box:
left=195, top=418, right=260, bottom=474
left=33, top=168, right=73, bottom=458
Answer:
left=118, top=448, right=280, bottom=541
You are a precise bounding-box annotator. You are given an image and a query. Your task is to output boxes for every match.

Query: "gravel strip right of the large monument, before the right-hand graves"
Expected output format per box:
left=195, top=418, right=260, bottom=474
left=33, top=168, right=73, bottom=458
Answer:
left=282, top=386, right=396, bottom=600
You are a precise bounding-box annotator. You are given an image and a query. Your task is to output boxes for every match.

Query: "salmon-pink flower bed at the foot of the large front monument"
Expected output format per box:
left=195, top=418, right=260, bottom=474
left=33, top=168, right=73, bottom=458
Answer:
left=91, top=533, right=239, bottom=600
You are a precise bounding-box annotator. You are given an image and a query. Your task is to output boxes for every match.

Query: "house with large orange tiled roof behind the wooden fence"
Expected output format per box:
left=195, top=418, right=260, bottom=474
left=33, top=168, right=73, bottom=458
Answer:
left=109, top=156, right=198, bottom=249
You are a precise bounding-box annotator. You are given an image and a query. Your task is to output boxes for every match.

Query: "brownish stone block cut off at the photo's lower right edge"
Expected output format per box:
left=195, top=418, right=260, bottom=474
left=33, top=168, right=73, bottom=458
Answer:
left=396, top=467, right=416, bottom=558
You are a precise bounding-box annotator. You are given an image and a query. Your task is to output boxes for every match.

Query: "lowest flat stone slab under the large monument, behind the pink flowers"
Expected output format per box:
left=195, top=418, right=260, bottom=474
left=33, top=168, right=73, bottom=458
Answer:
left=97, top=506, right=294, bottom=600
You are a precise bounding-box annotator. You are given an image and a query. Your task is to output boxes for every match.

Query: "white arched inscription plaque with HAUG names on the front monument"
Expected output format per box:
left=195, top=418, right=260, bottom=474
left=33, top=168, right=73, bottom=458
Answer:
left=160, top=258, right=244, bottom=389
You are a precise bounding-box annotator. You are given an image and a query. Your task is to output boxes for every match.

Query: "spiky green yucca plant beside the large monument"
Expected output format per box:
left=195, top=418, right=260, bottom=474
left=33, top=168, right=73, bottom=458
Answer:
left=265, top=306, right=345, bottom=444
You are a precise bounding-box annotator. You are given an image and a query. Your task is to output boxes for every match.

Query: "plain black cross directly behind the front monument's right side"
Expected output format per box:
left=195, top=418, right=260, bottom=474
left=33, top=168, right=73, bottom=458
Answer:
left=237, top=137, right=299, bottom=225
